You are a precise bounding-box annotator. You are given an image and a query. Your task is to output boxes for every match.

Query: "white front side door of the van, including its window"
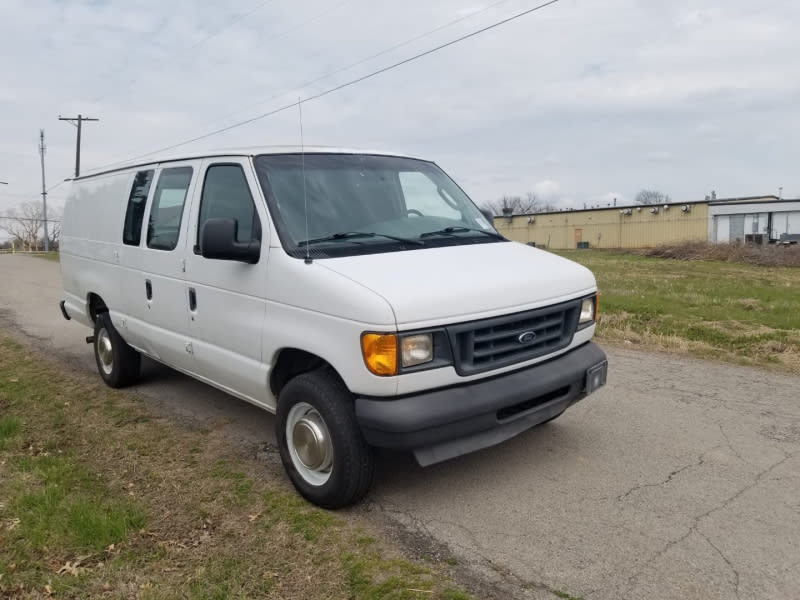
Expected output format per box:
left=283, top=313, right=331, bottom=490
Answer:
left=181, top=157, right=269, bottom=403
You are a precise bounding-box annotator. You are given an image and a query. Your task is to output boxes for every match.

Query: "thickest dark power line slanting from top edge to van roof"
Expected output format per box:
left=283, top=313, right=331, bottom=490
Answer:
left=90, top=0, right=560, bottom=168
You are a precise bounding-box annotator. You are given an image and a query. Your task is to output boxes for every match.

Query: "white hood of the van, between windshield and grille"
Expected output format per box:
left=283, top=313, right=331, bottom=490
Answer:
left=315, top=242, right=596, bottom=328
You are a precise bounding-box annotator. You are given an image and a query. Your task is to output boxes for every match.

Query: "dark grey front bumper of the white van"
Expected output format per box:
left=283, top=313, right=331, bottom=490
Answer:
left=355, top=342, right=607, bottom=466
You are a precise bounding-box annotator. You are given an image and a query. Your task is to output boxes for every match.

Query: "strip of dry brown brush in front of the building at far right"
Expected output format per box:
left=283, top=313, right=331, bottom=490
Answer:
left=636, top=242, right=800, bottom=267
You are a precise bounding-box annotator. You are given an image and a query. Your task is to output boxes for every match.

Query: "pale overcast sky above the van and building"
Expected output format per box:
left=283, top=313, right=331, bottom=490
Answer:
left=0, top=0, right=800, bottom=223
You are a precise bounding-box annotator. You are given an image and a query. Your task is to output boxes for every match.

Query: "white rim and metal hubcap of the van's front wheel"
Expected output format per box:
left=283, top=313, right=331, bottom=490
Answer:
left=286, top=402, right=333, bottom=485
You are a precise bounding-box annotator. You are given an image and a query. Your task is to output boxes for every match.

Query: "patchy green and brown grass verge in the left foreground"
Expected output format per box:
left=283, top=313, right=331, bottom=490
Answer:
left=0, top=332, right=469, bottom=600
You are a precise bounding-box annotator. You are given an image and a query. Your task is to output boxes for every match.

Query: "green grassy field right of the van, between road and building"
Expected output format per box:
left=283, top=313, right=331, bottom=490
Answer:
left=558, top=250, right=800, bottom=372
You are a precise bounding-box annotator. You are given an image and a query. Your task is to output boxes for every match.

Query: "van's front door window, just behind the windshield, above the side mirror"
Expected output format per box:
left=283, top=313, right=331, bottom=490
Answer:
left=197, top=165, right=261, bottom=246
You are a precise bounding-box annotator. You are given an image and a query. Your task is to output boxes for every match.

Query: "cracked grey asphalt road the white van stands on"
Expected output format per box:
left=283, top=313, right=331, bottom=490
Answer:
left=0, top=256, right=800, bottom=600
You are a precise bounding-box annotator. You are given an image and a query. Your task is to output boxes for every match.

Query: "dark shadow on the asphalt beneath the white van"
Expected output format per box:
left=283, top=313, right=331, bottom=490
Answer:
left=131, top=358, right=583, bottom=504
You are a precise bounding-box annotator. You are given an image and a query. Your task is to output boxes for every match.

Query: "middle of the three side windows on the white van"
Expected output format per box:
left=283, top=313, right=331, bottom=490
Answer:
left=147, top=167, right=192, bottom=250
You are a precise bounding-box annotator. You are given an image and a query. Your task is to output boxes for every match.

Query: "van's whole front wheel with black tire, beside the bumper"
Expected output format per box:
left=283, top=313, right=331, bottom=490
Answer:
left=275, top=368, right=375, bottom=509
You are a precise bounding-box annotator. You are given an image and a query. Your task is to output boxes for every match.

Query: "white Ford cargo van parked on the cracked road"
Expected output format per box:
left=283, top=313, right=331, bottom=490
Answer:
left=61, top=148, right=606, bottom=508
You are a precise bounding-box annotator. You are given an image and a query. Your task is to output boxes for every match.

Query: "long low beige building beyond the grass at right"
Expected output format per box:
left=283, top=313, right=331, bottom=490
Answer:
left=494, top=196, right=800, bottom=249
